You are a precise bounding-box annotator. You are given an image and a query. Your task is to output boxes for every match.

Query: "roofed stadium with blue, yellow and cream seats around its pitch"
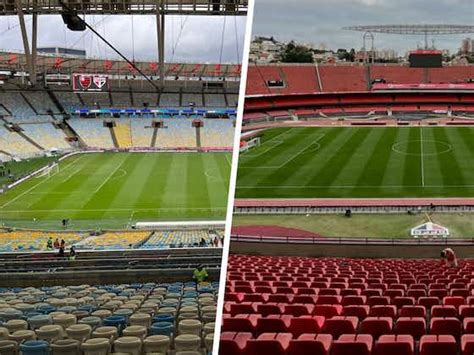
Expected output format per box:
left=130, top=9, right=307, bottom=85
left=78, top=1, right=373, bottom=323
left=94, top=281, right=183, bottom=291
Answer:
left=0, top=0, right=247, bottom=355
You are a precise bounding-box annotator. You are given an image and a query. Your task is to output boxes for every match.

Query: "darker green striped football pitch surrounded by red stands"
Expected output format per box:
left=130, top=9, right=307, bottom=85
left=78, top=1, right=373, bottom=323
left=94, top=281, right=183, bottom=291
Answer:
left=236, top=126, right=474, bottom=198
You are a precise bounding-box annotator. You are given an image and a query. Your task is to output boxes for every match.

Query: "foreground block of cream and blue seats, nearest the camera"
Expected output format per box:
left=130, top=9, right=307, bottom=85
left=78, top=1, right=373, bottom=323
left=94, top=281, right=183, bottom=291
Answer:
left=0, top=282, right=218, bottom=355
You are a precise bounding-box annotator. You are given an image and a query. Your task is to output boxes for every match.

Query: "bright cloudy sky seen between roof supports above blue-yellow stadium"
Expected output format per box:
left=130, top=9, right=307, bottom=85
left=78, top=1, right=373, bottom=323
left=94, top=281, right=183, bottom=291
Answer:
left=0, top=15, right=246, bottom=63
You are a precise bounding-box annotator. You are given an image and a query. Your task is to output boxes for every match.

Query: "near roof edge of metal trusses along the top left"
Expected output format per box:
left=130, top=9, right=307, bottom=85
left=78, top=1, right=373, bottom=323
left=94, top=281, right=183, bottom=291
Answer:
left=0, top=0, right=248, bottom=16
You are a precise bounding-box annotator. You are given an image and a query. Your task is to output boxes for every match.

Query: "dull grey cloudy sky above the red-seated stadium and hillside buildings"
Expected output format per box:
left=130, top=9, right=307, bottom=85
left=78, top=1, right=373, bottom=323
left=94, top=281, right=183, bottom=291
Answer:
left=253, top=0, right=474, bottom=53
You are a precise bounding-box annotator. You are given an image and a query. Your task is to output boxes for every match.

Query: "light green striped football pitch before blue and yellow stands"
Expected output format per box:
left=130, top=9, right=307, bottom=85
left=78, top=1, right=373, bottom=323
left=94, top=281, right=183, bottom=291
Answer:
left=0, top=153, right=231, bottom=229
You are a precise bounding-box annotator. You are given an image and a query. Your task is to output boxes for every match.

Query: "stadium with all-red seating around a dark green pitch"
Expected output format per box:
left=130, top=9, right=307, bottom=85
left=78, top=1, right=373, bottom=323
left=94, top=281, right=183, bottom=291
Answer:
left=220, top=24, right=474, bottom=355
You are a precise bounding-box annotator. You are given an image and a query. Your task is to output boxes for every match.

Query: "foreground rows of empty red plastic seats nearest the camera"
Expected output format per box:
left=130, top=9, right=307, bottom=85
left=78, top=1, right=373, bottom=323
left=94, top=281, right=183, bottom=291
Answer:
left=220, top=255, right=474, bottom=355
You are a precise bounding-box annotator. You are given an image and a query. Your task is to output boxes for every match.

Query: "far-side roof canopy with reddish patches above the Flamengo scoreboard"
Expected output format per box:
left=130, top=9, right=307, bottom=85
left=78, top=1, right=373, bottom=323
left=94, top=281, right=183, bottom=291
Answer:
left=0, top=52, right=241, bottom=78
